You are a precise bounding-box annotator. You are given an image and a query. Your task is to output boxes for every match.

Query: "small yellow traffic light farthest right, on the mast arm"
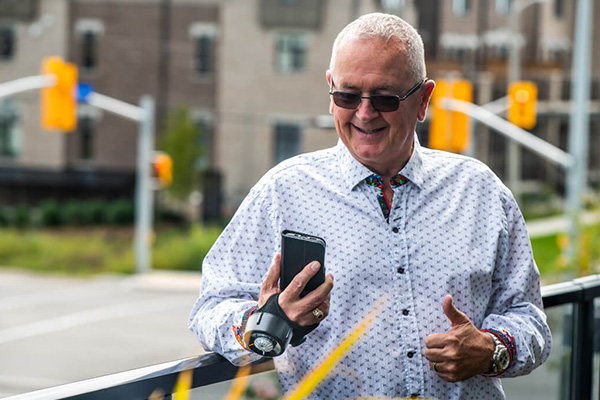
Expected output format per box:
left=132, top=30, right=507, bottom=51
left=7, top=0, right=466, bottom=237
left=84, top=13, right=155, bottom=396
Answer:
left=506, top=81, right=537, bottom=129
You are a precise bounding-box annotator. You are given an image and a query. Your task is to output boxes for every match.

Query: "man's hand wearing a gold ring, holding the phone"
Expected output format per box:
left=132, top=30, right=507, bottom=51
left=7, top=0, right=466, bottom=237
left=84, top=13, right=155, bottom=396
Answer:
left=258, top=254, right=333, bottom=326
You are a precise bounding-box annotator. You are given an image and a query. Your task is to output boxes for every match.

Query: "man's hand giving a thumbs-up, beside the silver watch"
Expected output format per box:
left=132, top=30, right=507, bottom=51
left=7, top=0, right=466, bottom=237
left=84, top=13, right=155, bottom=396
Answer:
left=425, top=295, right=495, bottom=382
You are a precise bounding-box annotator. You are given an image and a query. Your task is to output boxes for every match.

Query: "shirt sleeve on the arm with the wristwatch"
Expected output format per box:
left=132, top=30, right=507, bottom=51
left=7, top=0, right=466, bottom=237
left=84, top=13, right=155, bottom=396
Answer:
left=482, top=190, right=552, bottom=377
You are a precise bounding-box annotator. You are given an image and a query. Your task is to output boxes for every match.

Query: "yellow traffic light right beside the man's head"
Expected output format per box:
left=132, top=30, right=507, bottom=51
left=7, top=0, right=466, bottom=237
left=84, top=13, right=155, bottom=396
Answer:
left=429, top=80, right=473, bottom=153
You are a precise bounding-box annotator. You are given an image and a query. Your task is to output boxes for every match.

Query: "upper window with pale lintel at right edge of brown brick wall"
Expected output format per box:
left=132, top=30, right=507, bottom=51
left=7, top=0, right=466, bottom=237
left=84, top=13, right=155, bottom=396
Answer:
left=189, top=23, right=217, bottom=77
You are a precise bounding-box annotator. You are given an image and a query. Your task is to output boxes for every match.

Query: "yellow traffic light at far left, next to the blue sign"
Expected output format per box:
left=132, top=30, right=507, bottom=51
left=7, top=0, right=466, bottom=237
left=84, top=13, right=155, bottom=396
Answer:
left=41, top=56, right=77, bottom=132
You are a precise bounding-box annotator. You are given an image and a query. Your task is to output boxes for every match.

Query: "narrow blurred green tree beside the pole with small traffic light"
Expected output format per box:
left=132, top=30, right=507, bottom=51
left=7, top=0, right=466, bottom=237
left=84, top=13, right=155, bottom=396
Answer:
left=159, top=107, right=204, bottom=199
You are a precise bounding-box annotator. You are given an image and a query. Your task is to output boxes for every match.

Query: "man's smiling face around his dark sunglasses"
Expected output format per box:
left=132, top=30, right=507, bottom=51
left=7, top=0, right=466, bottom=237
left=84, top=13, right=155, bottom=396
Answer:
left=327, top=38, right=434, bottom=176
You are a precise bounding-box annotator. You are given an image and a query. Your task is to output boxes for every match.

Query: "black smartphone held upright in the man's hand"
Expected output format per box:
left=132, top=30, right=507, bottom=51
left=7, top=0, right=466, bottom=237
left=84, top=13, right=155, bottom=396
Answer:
left=279, top=230, right=325, bottom=297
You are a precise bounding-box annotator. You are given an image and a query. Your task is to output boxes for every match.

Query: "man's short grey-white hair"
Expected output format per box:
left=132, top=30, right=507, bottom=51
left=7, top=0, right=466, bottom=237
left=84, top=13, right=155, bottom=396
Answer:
left=329, top=13, right=427, bottom=80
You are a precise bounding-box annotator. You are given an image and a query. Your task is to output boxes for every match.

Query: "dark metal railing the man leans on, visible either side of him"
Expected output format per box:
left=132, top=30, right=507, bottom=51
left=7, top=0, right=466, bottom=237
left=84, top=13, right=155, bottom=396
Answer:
left=5, top=275, right=600, bottom=400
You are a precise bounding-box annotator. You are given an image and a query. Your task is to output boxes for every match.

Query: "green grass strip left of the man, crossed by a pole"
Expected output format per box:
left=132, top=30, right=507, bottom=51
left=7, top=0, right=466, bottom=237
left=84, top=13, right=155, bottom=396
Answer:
left=0, top=225, right=221, bottom=275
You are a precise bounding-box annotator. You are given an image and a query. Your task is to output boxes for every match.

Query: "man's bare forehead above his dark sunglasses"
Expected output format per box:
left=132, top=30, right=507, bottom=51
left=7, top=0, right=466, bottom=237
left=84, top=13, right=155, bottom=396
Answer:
left=332, top=38, right=408, bottom=89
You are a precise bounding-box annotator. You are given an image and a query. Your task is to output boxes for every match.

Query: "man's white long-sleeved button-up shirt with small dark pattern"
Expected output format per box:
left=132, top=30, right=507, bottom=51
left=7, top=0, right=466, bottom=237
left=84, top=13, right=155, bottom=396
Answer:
left=189, top=138, right=551, bottom=400
